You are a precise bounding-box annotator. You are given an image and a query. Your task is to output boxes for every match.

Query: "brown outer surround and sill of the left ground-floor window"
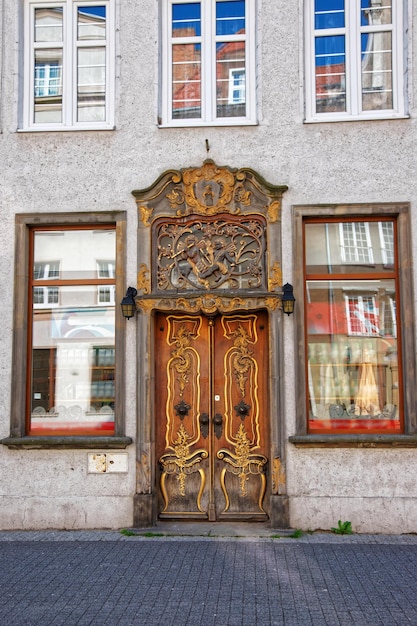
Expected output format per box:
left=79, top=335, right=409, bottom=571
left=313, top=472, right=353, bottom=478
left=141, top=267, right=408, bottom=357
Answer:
left=1, top=212, right=132, bottom=449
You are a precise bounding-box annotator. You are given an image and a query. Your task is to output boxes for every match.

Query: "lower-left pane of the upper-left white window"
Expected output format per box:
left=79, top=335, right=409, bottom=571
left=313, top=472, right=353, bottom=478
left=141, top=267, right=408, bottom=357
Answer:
left=34, top=49, right=62, bottom=124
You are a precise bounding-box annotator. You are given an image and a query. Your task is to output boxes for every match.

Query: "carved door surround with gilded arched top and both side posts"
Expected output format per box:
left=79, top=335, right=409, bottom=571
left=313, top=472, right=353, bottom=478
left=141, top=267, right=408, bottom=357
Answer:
left=132, top=160, right=289, bottom=528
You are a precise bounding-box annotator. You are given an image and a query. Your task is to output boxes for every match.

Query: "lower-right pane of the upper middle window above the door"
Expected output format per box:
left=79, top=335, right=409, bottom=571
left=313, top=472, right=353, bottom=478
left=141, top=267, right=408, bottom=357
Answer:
left=216, top=41, right=246, bottom=117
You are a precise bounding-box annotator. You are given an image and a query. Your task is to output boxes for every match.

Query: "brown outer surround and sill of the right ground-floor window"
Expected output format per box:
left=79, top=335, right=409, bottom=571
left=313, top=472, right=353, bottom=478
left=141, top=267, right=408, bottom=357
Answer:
left=289, top=203, right=417, bottom=446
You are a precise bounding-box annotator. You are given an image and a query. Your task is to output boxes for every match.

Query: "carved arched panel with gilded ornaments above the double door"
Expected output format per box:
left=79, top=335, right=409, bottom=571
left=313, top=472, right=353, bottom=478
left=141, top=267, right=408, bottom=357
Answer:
left=132, top=160, right=287, bottom=313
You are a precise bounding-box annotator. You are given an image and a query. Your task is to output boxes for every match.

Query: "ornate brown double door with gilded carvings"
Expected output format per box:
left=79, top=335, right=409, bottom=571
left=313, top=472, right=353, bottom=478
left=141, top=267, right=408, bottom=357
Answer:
left=155, top=311, right=269, bottom=521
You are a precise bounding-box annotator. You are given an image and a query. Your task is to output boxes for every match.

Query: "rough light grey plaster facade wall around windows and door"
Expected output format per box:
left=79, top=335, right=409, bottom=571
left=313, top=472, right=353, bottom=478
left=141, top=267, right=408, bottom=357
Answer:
left=0, top=0, right=417, bottom=533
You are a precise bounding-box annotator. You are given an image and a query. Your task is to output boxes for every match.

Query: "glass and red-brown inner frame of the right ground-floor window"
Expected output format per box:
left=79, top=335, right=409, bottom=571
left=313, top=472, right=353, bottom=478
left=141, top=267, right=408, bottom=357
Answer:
left=305, top=220, right=400, bottom=432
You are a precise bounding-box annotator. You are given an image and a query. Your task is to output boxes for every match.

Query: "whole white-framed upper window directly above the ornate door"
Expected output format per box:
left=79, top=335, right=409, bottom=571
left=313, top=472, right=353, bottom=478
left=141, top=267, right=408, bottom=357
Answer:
left=160, top=0, right=256, bottom=126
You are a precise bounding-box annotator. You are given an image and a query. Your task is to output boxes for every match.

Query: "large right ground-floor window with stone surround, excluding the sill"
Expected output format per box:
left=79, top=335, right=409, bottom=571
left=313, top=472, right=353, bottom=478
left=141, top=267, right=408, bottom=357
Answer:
left=296, top=206, right=416, bottom=434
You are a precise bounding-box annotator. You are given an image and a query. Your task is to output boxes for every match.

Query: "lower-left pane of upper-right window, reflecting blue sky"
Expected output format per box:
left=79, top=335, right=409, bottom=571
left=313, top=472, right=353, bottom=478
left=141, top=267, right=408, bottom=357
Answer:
left=315, top=35, right=346, bottom=113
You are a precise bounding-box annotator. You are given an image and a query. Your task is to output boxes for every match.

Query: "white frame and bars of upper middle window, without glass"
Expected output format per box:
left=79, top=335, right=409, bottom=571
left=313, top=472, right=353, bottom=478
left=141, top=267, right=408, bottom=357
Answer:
left=159, top=0, right=257, bottom=128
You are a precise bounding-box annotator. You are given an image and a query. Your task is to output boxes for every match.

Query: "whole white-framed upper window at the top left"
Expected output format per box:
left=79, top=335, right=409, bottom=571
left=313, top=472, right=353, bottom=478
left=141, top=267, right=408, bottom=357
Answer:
left=22, top=0, right=114, bottom=130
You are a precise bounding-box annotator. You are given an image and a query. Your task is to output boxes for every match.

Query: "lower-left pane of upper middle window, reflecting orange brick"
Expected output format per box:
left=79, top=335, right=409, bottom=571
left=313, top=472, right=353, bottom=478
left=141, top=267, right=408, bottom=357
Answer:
left=172, top=44, right=201, bottom=119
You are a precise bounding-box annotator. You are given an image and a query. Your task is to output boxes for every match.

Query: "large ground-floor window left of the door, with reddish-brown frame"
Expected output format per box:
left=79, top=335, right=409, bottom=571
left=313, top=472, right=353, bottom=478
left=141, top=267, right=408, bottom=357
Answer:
left=11, top=214, right=125, bottom=437
